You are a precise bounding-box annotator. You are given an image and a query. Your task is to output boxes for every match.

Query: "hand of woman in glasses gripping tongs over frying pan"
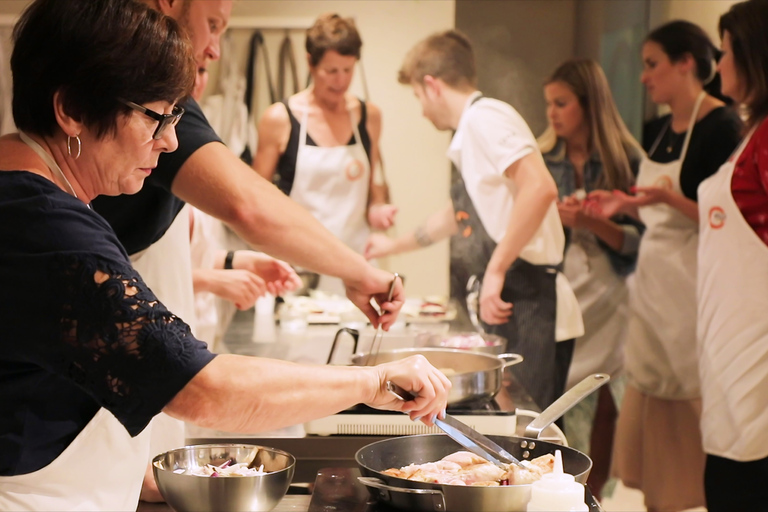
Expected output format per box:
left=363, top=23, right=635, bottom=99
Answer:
left=366, top=355, right=451, bottom=425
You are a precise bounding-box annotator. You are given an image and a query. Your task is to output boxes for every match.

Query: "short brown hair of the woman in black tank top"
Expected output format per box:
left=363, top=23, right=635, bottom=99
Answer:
left=305, top=14, right=363, bottom=66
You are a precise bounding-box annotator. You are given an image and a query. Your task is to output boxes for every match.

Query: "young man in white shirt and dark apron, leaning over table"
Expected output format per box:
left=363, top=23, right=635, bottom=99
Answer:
left=366, top=30, right=584, bottom=408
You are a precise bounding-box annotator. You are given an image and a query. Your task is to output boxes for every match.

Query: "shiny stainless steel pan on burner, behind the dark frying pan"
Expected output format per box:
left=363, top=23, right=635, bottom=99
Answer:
left=328, top=328, right=523, bottom=405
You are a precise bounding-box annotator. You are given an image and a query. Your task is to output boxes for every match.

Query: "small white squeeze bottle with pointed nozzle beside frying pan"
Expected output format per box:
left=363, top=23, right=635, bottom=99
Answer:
left=527, top=450, right=589, bottom=512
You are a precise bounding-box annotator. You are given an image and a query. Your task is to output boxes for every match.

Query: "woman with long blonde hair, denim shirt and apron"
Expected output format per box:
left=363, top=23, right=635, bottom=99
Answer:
left=539, top=59, right=642, bottom=496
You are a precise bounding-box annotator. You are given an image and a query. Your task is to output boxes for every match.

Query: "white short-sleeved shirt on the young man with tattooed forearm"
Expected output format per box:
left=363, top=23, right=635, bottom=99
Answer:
left=447, top=92, right=584, bottom=341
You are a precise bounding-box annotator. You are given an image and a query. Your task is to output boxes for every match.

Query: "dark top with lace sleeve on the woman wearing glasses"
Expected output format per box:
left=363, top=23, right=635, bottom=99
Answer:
left=0, top=171, right=214, bottom=476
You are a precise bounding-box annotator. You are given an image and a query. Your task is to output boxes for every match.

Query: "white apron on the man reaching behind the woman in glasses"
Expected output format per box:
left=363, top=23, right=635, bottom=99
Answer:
left=131, top=206, right=195, bottom=465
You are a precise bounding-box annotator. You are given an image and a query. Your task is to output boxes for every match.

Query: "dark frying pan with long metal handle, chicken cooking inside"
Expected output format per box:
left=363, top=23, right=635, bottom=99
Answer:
left=355, top=374, right=609, bottom=512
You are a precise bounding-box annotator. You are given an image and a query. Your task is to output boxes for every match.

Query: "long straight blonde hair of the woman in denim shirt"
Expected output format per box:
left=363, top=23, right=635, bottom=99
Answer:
left=538, top=59, right=643, bottom=192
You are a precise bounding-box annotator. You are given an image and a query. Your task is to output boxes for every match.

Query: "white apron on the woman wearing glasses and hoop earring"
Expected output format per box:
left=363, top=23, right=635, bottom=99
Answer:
left=0, top=409, right=150, bottom=512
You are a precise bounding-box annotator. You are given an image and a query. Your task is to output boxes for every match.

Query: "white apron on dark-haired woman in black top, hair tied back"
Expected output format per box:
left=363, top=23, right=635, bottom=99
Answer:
left=625, top=92, right=705, bottom=400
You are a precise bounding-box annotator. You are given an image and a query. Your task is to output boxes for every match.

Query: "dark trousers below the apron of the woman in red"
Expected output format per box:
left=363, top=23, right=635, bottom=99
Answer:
left=704, top=455, right=768, bottom=512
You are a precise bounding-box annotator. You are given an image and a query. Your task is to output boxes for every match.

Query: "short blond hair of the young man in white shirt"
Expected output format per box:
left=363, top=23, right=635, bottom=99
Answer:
left=397, top=30, right=477, bottom=89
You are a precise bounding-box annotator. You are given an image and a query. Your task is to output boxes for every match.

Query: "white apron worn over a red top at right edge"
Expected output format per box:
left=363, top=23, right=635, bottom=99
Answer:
left=698, top=127, right=768, bottom=462
